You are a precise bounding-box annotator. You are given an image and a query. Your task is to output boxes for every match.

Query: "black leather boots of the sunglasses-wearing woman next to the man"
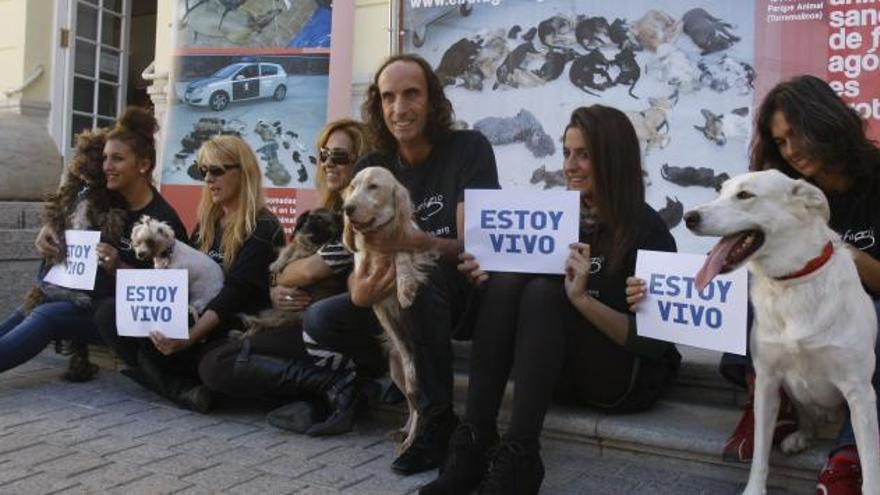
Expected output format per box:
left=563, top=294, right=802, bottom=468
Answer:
left=235, top=354, right=365, bottom=436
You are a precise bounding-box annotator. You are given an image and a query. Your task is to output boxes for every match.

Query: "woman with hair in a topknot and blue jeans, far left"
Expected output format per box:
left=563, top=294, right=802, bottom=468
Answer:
left=0, top=107, right=186, bottom=375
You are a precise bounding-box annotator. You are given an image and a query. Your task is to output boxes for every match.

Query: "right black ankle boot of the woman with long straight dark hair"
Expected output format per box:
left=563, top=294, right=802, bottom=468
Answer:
left=477, top=438, right=544, bottom=495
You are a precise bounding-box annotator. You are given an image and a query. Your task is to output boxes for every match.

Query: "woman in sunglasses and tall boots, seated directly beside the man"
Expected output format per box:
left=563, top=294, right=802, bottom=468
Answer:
left=199, top=119, right=378, bottom=435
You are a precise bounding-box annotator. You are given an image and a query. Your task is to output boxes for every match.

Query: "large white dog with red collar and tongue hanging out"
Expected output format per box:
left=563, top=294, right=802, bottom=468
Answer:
left=685, top=170, right=880, bottom=495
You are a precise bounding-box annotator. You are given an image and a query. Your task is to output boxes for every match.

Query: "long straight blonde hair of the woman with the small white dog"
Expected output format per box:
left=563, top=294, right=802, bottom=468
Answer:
left=197, top=136, right=266, bottom=269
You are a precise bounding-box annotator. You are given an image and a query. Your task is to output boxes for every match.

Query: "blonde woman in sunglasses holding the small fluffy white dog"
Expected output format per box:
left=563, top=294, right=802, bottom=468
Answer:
left=96, top=136, right=283, bottom=412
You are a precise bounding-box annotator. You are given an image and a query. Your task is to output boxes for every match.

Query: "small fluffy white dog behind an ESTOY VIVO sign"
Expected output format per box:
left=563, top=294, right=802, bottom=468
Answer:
left=131, top=215, right=224, bottom=317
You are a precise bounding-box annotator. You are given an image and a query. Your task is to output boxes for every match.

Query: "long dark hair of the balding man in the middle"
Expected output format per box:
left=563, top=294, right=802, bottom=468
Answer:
left=361, top=53, right=453, bottom=151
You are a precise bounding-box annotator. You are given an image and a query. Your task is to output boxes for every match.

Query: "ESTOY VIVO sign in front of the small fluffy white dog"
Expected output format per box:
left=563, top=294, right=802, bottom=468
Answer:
left=116, top=269, right=189, bottom=339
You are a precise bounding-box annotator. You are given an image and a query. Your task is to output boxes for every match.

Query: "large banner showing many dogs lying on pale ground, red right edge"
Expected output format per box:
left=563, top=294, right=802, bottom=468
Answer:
left=395, top=0, right=880, bottom=254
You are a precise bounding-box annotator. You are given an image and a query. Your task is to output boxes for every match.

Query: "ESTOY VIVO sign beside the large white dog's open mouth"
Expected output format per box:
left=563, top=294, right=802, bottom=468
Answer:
left=635, top=250, right=748, bottom=355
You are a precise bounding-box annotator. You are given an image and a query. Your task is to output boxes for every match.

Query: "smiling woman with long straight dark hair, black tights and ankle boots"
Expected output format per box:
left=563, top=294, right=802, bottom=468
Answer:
left=420, top=105, right=681, bottom=494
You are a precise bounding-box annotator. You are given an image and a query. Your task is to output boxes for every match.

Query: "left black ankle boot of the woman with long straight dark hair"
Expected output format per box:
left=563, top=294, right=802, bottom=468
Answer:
left=419, top=423, right=498, bottom=495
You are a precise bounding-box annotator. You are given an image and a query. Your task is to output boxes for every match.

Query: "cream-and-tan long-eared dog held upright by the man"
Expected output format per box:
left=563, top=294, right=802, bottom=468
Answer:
left=343, top=167, right=436, bottom=452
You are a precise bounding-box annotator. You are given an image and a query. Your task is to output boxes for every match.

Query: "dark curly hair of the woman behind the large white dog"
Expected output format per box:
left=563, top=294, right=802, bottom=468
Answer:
left=751, top=75, right=880, bottom=186
